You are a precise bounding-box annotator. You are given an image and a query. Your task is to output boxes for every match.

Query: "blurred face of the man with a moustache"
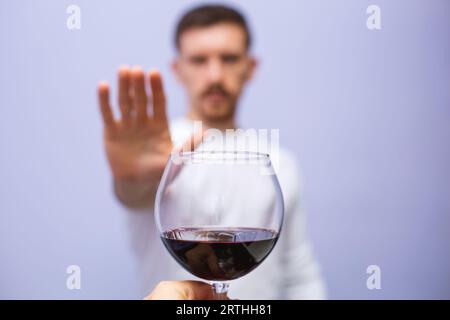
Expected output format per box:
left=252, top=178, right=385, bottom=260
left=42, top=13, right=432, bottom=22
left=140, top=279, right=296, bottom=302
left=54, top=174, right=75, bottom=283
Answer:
left=174, top=23, right=256, bottom=122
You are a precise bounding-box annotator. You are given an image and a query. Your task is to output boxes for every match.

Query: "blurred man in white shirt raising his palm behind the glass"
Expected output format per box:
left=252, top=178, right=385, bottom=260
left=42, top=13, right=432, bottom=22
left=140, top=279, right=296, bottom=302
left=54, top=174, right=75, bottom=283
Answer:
left=99, top=5, right=324, bottom=299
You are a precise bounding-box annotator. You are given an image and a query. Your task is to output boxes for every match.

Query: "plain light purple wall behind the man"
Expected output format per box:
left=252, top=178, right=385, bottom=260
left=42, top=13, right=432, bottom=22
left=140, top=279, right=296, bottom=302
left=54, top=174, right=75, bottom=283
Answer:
left=0, top=0, right=450, bottom=299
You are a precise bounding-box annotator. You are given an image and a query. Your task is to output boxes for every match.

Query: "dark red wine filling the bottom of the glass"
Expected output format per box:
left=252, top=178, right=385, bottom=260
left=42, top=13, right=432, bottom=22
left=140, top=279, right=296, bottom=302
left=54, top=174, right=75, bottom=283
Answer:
left=161, top=228, right=278, bottom=281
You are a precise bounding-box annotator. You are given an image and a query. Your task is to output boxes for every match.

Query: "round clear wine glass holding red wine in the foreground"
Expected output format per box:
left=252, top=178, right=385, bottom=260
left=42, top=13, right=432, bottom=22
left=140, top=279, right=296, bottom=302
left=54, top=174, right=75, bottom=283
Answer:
left=155, top=151, right=284, bottom=299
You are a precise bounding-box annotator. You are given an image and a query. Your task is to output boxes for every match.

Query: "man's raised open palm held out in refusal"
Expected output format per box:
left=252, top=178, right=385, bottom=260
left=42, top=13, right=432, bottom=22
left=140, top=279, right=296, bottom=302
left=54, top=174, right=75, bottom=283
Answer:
left=98, top=67, right=199, bottom=208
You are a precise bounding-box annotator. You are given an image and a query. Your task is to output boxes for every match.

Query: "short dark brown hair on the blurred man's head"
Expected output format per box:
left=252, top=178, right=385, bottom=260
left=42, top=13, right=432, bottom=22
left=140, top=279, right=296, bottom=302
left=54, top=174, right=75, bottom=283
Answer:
left=175, top=5, right=252, bottom=50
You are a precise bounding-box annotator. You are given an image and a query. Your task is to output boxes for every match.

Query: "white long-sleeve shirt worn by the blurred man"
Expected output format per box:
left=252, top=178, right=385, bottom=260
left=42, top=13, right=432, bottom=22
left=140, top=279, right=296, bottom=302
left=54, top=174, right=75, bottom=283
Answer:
left=126, top=118, right=325, bottom=299
